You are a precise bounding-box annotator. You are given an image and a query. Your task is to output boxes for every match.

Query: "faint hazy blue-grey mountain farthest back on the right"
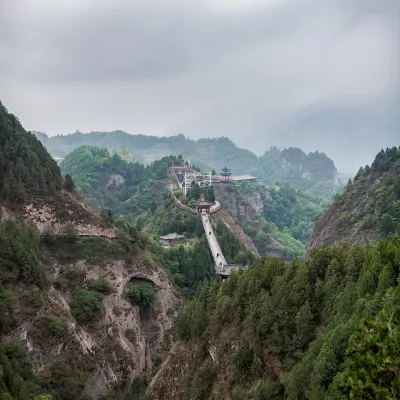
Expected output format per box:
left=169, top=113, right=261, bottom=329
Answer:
left=260, top=96, right=400, bottom=172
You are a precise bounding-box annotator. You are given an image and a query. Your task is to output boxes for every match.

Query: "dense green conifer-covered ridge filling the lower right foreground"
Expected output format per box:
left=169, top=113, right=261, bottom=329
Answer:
left=150, top=237, right=400, bottom=400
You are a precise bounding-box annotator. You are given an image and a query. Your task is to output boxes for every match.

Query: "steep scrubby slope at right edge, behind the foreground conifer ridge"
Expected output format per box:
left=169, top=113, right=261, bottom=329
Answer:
left=310, top=147, right=400, bottom=248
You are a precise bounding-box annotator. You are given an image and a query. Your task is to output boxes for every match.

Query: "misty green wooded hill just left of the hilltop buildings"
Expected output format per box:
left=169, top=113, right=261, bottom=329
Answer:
left=61, top=146, right=182, bottom=220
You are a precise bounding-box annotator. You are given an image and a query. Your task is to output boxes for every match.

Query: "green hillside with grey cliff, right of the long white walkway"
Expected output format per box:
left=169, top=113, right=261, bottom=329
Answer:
left=214, top=183, right=329, bottom=260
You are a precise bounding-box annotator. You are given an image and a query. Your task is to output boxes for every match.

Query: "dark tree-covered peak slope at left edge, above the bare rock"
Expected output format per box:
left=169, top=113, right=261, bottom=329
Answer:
left=0, top=103, right=61, bottom=205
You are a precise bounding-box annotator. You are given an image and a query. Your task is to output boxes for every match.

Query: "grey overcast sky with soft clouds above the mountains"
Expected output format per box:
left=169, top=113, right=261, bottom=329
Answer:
left=0, top=0, right=400, bottom=152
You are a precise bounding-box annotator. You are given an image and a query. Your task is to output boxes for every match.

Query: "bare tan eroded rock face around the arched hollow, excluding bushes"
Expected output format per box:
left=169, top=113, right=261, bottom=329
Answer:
left=8, top=248, right=179, bottom=399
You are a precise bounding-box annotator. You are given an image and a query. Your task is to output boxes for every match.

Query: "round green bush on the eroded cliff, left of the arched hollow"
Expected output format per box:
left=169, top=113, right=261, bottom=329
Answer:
left=69, top=290, right=104, bottom=324
